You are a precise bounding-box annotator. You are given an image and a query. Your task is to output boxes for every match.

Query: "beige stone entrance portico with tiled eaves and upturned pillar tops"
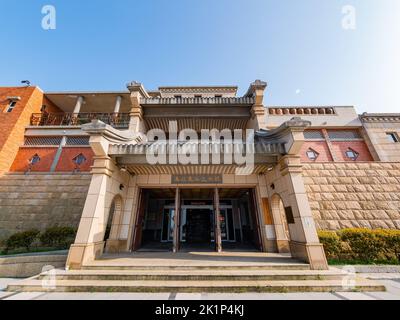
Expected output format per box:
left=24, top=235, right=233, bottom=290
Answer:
left=67, top=83, right=327, bottom=269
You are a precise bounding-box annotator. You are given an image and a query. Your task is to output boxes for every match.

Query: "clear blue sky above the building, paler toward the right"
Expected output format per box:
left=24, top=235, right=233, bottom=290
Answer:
left=0, top=0, right=400, bottom=112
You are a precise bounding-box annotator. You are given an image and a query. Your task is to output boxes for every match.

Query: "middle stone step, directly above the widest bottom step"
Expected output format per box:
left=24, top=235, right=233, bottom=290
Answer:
left=38, top=269, right=345, bottom=281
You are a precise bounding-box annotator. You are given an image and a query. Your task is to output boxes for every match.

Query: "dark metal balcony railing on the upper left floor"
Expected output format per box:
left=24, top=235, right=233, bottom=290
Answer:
left=30, top=113, right=130, bottom=129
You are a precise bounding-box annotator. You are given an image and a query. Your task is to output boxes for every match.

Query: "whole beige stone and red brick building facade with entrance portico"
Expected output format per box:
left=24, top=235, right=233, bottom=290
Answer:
left=0, top=81, right=400, bottom=269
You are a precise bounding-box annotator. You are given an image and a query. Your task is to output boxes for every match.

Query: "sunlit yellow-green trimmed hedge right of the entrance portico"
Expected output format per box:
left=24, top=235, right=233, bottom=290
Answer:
left=318, top=229, right=400, bottom=263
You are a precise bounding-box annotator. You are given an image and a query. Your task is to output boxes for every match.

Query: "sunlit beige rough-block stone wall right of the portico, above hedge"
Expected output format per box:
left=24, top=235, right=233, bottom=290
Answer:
left=303, top=162, right=400, bottom=230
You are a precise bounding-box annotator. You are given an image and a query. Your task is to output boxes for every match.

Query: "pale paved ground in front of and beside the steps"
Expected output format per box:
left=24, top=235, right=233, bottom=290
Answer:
left=0, top=273, right=400, bottom=300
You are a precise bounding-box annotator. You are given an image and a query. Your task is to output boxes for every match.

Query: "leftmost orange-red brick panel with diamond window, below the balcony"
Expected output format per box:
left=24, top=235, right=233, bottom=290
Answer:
left=10, top=147, right=57, bottom=172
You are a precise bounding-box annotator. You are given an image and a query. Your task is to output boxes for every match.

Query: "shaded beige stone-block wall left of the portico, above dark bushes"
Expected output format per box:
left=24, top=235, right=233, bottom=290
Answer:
left=0, top=174, right=91, bottom=240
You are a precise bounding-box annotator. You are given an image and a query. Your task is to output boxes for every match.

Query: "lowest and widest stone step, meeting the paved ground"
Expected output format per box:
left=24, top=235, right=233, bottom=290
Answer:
left=7, top=279, right=385, bottom=293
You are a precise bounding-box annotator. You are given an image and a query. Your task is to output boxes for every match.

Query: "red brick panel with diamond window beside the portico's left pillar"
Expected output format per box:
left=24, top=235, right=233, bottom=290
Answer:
left=56, top=147, right=94, bottom=172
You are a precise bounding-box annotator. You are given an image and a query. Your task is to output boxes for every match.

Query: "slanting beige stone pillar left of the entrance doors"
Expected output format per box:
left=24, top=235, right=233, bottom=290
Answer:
left=67, top=156, right=113, bottom=269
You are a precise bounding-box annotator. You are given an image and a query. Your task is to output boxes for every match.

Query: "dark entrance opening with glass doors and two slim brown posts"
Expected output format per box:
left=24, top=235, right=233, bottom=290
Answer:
left=132, top=188, right=262, bottom=252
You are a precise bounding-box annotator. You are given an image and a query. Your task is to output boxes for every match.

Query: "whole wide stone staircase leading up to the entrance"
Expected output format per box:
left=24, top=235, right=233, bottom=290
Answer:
left=7, top=252, right=385, bottom=293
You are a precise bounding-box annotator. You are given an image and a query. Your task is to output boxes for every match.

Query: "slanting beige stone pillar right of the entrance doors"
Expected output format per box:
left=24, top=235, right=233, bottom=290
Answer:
left=279, top=155, right=328, bottom=270
